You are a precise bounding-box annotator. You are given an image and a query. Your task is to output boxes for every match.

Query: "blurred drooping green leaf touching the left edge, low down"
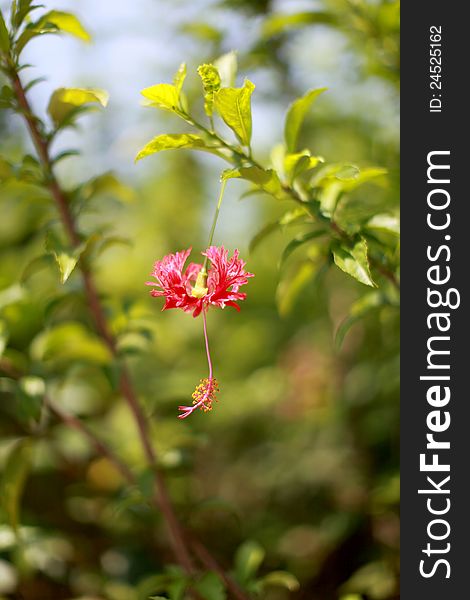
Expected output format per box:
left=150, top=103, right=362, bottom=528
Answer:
left=0, top=439, right=32, bottom=531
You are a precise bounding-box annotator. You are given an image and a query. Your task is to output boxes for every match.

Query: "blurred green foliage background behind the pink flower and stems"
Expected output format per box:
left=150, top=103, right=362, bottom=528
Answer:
left=0, top=0, right=399, bottom=600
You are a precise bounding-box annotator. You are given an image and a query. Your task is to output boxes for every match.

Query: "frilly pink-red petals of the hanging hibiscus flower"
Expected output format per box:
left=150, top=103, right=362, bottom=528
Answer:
left=146, top=246, right=253, bottom=317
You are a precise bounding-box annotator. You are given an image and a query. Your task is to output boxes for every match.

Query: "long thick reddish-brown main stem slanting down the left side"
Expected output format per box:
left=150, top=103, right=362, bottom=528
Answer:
left=11, top=72, right=194, bottom=573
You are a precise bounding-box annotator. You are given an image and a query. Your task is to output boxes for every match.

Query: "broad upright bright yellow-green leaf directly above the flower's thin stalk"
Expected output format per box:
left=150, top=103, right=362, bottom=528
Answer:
left=214, top=79, right=255, bottom=146
